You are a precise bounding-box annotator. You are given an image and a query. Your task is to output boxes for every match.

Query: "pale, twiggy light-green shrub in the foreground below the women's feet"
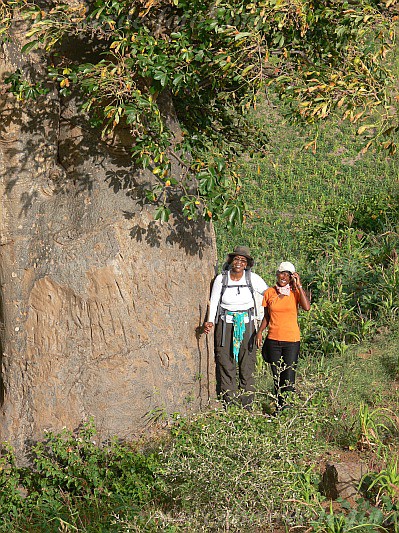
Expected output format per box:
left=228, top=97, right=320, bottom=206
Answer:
left=158, top=402, right=322, bottom=531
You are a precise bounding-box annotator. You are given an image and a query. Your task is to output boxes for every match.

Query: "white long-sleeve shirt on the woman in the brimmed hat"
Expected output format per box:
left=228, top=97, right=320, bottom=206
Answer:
left=208, top=272, right=268, bottom=323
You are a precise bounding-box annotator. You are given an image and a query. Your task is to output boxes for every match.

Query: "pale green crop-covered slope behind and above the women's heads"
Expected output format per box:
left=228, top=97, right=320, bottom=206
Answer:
left=216, top=96, right=399, bottom=279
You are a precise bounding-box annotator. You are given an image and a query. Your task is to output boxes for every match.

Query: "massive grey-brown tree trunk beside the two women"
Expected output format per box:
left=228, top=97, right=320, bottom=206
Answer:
left=0, top=32, right=216, bottom=451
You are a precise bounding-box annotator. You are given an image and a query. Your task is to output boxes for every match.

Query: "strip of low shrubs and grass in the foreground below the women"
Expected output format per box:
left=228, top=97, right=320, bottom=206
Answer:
left=0, top=339, right=399, bottom=533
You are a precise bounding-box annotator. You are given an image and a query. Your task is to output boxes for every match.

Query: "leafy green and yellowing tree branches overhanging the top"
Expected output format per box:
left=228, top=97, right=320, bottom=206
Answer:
left=0, top=0, right=397, bottom=224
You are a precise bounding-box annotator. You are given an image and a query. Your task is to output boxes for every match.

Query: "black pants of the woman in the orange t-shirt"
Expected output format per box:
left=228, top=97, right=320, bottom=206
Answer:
left=262, top=338, right=300, bottom=408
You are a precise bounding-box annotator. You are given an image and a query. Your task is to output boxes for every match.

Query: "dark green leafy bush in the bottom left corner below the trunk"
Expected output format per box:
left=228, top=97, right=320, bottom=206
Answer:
left=0, top=422, right=161, bottom=531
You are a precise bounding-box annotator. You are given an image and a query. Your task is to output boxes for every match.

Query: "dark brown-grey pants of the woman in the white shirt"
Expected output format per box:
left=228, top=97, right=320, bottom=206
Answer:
left=215, top=320, right=256, bottom=408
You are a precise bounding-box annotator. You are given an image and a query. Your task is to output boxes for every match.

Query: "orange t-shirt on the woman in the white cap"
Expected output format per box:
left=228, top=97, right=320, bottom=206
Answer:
left=262, top=287, right=300, bottom=342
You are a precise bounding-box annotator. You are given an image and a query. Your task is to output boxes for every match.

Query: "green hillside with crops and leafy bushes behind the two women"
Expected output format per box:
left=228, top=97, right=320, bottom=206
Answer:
left=216, top=97, right=399, bottom=355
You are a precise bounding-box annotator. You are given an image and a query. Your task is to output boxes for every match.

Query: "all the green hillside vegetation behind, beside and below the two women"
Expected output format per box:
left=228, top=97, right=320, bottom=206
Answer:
left=0, top=102, right=399, bottom=533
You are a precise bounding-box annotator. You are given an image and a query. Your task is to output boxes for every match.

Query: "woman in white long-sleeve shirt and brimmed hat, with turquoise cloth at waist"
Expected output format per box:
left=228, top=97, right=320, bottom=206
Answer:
left=204, top=246, right=268, bottom=409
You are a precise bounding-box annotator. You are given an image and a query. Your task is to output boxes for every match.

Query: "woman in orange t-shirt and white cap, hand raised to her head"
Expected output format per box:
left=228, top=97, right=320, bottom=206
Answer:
left=255, top=261, right=310, bottom=410
